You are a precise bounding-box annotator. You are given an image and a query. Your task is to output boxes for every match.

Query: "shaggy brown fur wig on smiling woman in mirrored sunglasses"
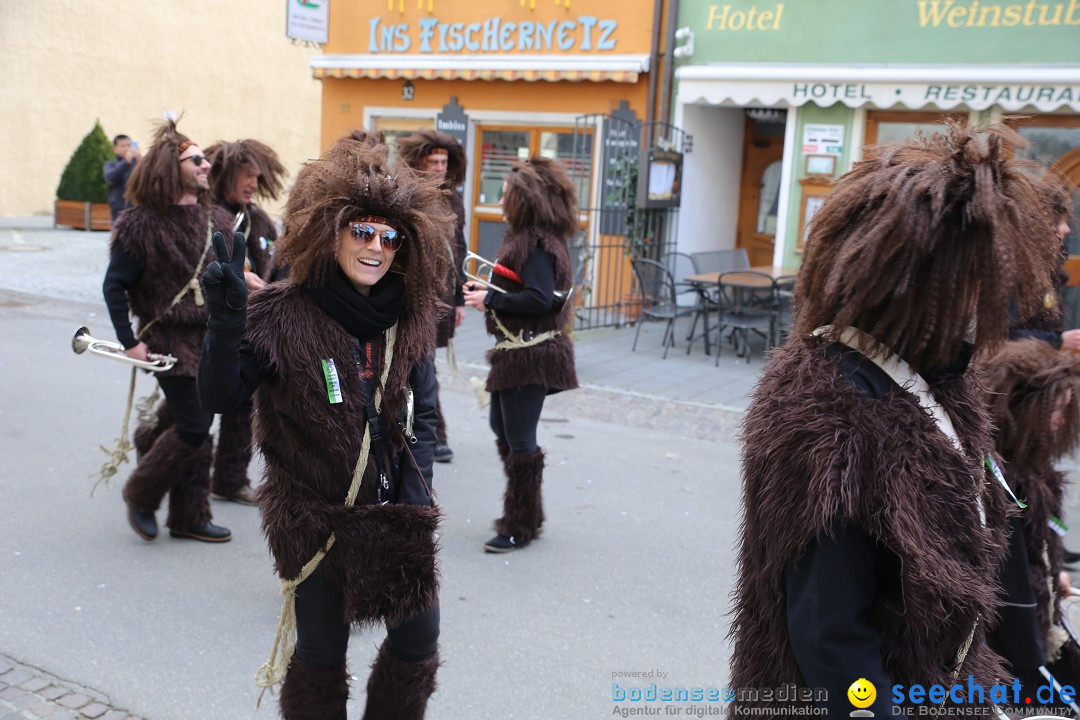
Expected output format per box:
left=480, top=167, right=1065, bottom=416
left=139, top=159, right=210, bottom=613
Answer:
left=276, top=131, right=454, bottom=309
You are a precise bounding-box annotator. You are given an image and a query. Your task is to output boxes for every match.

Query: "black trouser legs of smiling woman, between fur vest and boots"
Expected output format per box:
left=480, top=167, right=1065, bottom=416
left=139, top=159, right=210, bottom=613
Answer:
left=296, top=575, right=440, bottom=669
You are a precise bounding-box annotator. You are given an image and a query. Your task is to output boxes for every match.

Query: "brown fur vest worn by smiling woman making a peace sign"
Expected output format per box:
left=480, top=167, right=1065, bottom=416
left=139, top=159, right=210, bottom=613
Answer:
left=246, top=283, right=438, bottom=624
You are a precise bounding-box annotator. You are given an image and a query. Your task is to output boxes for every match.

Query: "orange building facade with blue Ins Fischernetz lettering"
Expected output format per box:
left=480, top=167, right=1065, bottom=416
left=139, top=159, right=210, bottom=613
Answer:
left=311, top=0, right=664, bottom=321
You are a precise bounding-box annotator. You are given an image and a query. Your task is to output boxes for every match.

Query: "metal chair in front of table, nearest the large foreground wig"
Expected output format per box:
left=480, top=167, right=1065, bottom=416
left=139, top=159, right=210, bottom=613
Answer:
left=716, top=270, right=780, bottom=366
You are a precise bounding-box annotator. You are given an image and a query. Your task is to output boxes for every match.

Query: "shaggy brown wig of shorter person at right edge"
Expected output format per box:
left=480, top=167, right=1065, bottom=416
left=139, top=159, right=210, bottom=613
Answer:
left=984, top=339, right=1080, bottom=475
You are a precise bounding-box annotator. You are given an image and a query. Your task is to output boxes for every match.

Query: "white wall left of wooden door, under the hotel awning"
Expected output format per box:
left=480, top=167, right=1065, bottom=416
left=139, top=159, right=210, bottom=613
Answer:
left=675, top=105, right=745, bottom=253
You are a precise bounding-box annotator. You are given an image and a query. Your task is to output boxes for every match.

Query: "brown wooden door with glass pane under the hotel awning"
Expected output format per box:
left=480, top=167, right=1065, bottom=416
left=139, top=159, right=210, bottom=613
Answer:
left=735, top=118, right=784, bottom=266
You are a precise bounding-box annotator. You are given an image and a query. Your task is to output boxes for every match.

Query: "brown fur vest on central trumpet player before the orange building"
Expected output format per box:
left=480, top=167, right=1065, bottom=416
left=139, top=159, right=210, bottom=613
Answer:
left=486, top=230, right=578, bottom=393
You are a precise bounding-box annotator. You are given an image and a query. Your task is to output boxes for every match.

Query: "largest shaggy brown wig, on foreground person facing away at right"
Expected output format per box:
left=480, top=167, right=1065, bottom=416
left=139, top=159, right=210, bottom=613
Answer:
left=794, top=123, right=1059, bottom=372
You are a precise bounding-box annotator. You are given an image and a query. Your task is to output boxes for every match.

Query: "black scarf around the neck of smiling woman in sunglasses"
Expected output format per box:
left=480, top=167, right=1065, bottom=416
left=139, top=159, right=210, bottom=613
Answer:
left=303, top=268, right=405, bottom=340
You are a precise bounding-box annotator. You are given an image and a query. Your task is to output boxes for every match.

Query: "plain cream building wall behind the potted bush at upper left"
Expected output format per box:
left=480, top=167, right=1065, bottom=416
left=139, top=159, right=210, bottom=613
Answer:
left=0, top=0, right=322, bottom=220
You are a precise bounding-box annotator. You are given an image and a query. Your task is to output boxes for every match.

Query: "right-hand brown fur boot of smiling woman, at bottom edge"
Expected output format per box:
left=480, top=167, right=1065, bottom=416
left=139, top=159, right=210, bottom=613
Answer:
left=364, top=641, right=438, bottom=720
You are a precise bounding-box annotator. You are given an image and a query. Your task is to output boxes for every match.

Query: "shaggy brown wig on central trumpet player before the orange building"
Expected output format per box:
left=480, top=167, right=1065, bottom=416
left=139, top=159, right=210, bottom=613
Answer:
left=502, top=155, right=580, bottom=239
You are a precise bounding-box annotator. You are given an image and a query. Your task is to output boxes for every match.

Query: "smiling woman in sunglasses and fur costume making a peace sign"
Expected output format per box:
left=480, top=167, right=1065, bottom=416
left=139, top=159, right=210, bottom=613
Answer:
left=199, top=133, right=453, bottom=720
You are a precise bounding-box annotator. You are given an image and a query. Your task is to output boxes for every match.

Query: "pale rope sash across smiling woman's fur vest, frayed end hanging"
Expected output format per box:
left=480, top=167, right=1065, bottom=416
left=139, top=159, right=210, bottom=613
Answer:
left=255, top=324, right=397, bottom=707
